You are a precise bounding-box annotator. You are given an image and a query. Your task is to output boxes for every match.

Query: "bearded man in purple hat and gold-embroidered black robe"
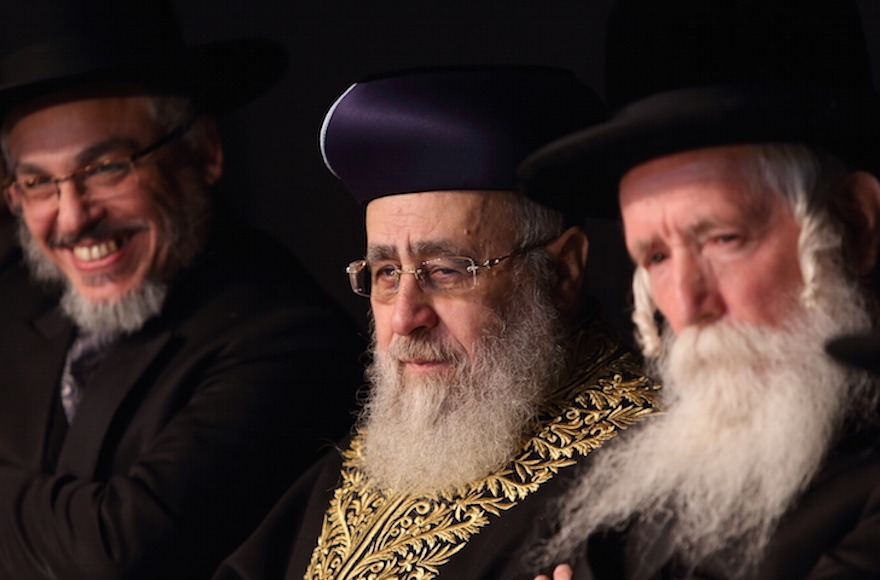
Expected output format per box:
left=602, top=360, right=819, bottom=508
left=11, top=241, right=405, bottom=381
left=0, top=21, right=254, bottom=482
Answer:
left=217, top=67, right=655, bottom=580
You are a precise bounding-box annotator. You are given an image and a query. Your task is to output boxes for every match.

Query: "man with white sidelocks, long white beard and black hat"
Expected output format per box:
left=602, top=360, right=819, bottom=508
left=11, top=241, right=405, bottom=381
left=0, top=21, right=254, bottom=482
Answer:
left=521, top=0, right=880, bottom=579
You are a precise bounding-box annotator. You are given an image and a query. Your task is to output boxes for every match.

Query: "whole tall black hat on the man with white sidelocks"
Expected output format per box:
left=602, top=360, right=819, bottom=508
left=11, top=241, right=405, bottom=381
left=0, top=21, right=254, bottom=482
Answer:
left=520, top=0, right=880, bottom=217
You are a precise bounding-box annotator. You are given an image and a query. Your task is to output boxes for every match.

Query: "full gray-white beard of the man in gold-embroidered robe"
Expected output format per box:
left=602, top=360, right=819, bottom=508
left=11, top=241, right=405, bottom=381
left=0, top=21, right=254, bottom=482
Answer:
left=360, top=280, right=565, bottom=493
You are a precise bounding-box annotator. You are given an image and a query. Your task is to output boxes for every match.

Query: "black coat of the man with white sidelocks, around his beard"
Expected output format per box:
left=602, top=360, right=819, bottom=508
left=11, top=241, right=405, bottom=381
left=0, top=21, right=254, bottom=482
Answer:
left=589, top=432, right=880, bottom=580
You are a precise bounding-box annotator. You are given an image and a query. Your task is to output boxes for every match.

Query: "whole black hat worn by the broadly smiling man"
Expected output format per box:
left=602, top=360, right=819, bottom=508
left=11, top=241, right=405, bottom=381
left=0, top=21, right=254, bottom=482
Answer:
left=0, top=0, right=288, bottom=116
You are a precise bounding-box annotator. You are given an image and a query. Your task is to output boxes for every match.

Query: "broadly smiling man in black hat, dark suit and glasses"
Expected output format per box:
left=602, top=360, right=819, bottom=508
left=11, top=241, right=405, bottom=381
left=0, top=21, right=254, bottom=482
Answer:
left=0, top=0, right=362, bottom=580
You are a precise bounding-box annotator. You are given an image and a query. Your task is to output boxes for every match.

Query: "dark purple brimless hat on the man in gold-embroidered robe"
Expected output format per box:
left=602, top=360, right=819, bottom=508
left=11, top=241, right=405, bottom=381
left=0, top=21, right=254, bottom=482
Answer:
left=320, top=65, right=606, bottom=204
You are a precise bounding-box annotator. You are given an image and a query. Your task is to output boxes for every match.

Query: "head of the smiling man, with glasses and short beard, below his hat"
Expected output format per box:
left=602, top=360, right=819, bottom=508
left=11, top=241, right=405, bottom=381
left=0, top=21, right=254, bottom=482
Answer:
left=3, top=86, right=211, bottom=334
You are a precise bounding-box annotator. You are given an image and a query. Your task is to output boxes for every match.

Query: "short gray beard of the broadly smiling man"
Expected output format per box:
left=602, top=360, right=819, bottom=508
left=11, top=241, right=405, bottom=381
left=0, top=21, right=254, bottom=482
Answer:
left=18, top=218, right=168, bottom=335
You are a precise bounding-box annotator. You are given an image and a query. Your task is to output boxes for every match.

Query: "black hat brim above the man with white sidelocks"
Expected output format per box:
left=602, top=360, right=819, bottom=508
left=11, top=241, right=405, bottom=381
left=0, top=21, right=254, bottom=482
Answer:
left=519, top=86, right=880, bottom=218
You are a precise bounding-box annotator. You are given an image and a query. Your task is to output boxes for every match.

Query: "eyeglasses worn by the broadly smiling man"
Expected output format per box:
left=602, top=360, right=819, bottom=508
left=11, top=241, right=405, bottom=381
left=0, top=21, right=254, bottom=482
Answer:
left=4, top=122, right=192, bottom=210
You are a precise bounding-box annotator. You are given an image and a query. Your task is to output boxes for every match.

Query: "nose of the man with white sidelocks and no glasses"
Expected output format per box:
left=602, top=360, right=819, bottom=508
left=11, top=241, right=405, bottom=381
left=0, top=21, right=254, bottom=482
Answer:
left=658, top=254, right=724, bottom=334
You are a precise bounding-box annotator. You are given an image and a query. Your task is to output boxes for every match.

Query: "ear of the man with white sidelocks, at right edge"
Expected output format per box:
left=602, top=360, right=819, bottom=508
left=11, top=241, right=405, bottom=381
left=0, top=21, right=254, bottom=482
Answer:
left=837, top=171, right=880, bottom=276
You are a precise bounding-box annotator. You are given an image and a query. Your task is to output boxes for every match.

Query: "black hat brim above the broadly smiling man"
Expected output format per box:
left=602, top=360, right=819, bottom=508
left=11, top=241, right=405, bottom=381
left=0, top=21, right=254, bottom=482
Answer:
left=0, top=38, right=288, bottom=117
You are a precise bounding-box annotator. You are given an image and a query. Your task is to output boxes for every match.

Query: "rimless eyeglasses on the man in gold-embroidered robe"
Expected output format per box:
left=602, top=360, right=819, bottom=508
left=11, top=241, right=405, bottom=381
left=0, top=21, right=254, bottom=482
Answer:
left=345, top=240, right=552, bottom=302
